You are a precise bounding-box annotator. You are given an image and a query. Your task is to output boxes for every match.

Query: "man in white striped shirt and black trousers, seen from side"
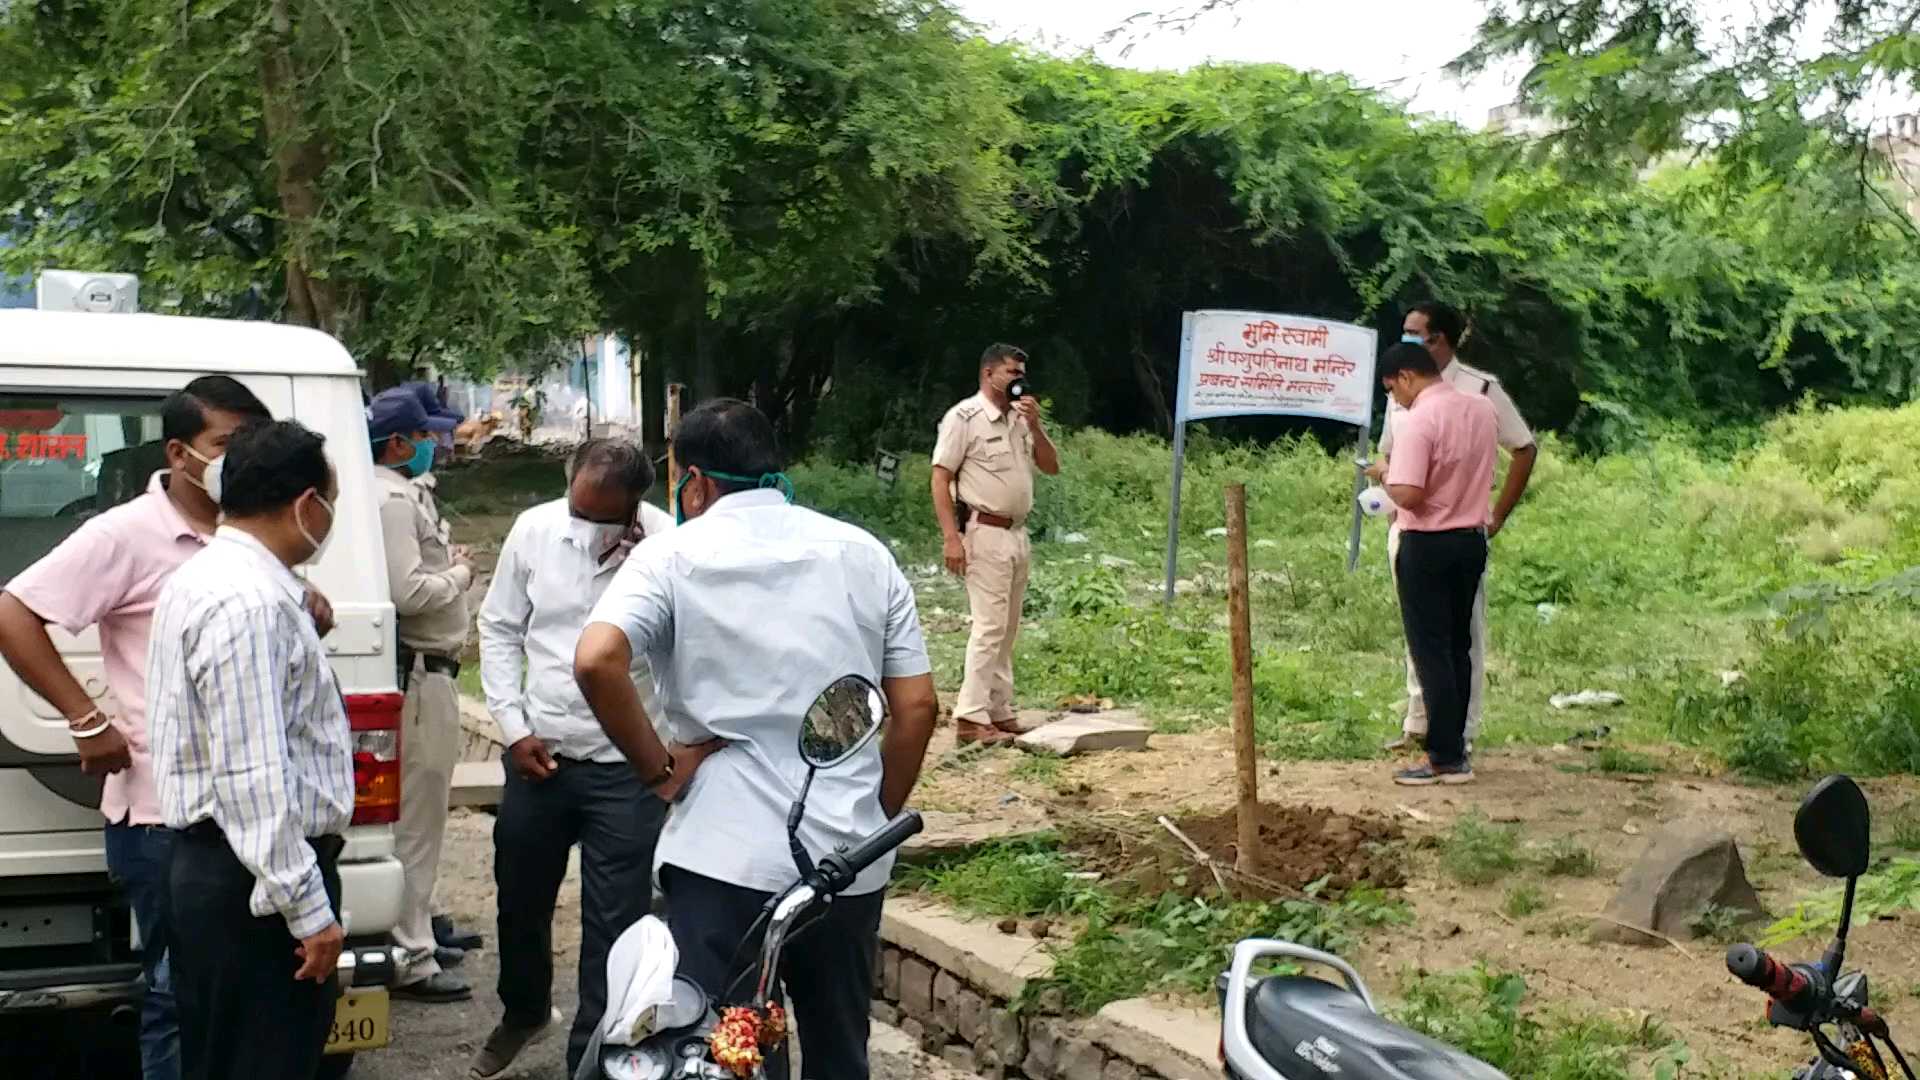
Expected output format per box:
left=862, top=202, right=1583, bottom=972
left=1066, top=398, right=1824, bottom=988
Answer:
left=148, top=421, right=353, bottom=1080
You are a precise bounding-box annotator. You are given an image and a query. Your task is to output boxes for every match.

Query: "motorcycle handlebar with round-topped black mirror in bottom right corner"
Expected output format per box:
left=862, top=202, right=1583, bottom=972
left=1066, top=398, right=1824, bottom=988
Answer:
left=1726, top=776, right=1914, bottom=1080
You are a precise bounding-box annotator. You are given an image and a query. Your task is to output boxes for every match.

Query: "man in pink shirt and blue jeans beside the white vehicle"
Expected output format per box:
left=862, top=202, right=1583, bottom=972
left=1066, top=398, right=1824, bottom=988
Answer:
left=0, top=375, right=274, bottom=1080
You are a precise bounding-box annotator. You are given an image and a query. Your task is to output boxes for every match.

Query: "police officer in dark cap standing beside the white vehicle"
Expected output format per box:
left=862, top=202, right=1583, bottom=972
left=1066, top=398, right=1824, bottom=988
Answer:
left=367, top=386, right=474, bottom=1001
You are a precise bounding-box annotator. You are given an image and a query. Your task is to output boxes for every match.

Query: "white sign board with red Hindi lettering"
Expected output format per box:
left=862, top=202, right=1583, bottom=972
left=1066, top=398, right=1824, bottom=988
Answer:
left=1181, top=311, right=1380, bottom=429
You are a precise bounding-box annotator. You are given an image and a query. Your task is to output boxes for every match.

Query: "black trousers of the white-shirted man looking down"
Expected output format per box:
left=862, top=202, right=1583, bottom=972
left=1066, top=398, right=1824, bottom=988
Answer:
left=493, top=757, right=666, bottom=1076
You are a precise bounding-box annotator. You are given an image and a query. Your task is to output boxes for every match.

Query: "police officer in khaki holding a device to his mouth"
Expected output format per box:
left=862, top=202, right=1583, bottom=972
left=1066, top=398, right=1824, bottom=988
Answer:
left=933, top=344, right=1060, bottom=744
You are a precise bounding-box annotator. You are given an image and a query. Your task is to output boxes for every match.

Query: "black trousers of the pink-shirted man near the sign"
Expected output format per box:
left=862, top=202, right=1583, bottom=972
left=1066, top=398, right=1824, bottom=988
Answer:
left=1394, top=528, right=1486, bottom=767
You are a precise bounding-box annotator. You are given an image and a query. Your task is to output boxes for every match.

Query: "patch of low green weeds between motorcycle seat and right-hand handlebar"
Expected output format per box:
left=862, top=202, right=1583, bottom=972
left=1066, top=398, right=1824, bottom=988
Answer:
left=1392, top=967, right=1690, bottom=1080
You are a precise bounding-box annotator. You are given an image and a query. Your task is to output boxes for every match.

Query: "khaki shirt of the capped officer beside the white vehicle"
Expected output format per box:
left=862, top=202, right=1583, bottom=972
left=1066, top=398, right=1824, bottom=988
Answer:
left=374, top=465, right=474, bottom=659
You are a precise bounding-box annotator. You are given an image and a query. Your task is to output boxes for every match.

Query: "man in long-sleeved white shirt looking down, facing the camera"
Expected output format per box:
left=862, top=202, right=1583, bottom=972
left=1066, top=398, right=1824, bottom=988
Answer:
left=472, top=438, right=674, bottom=1080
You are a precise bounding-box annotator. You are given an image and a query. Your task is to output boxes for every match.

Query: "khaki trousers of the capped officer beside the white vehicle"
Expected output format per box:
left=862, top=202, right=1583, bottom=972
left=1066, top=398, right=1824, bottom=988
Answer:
left=394, top=661, right=461, bottom=986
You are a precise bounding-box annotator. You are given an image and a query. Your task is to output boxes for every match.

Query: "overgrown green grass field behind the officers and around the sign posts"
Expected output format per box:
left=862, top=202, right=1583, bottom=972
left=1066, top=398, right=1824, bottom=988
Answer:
left=793, top=405, right=1920, bottom=764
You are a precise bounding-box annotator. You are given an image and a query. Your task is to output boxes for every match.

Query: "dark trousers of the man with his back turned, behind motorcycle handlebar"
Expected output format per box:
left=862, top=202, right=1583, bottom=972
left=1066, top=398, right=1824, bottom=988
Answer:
left=660, top=867, right=885, bottom=1080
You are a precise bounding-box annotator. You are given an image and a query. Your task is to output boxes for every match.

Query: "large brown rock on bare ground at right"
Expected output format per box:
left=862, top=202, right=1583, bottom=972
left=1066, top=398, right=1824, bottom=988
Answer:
left=1592, top=821, right=1764, bottom=945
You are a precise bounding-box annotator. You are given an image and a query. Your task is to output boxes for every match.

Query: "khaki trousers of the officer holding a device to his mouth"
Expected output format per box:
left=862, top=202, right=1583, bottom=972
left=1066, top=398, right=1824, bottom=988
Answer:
left=954, top=523, right=1033, bottom=724
